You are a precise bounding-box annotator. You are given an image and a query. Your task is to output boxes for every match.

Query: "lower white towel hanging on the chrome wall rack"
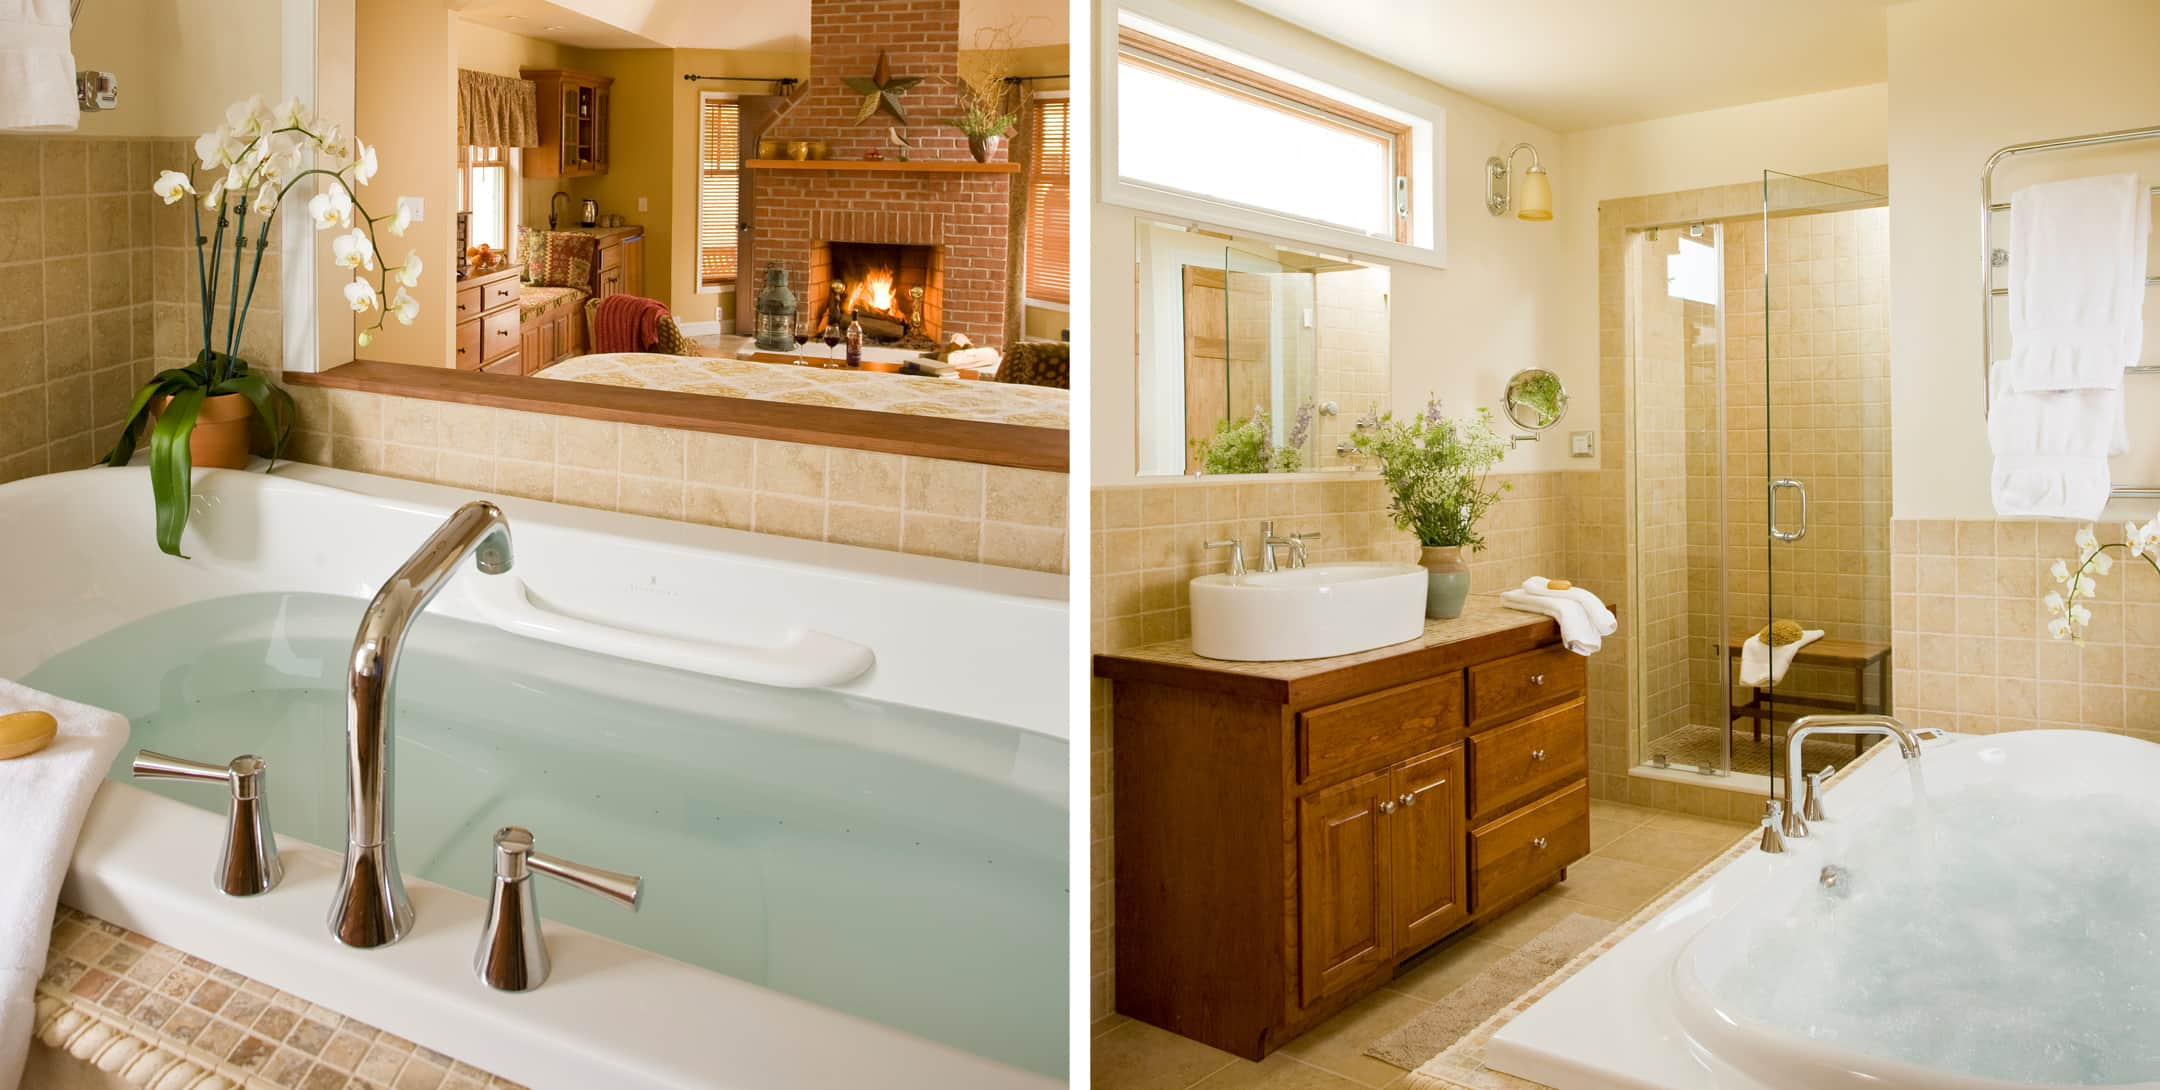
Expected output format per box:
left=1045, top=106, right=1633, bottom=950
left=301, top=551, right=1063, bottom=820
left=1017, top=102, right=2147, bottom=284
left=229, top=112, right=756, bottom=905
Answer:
left=1987, top=363, right=2130, bottom=522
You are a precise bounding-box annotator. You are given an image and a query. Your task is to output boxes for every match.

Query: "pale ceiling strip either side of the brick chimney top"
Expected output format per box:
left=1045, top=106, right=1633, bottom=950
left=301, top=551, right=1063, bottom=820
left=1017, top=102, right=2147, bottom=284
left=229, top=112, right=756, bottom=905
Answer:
left=454, top=0, right=1071, bottom=52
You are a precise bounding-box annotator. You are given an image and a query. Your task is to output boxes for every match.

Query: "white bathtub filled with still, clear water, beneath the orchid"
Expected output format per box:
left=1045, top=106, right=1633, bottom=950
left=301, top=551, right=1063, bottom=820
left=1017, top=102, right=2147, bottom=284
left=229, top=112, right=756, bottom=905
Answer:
left=0, top=466, right=1069, bottom=1090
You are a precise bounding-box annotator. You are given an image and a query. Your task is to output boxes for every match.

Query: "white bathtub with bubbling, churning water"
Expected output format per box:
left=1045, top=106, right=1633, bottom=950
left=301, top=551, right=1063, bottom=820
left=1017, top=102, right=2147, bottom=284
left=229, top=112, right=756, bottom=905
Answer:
left=1486, top=732, right=2160, bottom=1090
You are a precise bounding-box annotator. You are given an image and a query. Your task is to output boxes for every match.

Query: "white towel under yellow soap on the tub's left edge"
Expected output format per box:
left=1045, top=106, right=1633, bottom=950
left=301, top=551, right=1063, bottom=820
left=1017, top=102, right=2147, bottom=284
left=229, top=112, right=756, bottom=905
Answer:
left=0, top=680, right=127, bottom=1090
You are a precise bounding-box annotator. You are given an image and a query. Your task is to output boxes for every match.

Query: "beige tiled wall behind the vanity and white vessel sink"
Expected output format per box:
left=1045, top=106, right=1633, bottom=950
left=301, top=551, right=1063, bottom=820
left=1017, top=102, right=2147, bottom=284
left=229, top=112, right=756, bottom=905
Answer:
left=1089, top=473, right=1596, bottom=1021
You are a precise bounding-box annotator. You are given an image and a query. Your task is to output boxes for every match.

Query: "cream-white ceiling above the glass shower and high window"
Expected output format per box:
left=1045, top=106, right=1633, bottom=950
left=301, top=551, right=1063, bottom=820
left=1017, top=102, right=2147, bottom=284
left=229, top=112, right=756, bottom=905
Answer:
left=1242, top=0, right=1896, bottom=132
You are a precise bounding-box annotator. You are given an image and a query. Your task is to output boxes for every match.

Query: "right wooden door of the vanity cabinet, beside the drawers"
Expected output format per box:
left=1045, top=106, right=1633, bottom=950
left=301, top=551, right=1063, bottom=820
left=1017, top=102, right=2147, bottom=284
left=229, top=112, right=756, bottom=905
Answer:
left=1387, top=745, right=1471, bottom=954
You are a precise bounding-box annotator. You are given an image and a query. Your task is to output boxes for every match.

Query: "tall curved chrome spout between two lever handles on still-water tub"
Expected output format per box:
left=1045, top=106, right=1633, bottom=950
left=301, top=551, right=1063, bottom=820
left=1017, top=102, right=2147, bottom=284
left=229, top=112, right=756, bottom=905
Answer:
left=330, top=501, right=510, bottom=948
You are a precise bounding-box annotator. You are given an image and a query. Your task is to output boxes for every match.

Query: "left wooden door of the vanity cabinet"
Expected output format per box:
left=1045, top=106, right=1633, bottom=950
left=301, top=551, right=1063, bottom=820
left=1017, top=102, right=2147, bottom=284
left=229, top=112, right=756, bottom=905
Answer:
left=1298, top=773, right=1395, bottom=1004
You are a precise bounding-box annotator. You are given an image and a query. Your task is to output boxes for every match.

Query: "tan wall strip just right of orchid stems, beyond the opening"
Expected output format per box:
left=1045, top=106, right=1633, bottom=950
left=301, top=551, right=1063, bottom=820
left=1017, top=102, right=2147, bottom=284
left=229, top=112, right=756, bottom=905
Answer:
left=356, top=0, right=458, bottom=367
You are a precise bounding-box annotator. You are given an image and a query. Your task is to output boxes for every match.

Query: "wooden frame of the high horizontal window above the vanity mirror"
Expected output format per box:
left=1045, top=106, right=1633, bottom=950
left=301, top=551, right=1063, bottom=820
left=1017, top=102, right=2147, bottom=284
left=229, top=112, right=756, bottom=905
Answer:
left=1112, top=26, right=1417, bottom=246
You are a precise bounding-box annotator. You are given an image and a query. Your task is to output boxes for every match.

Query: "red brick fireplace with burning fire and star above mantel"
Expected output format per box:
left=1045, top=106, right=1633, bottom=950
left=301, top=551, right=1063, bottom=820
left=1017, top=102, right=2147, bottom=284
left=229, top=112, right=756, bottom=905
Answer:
left=743, top=0, right=1015, bottom=343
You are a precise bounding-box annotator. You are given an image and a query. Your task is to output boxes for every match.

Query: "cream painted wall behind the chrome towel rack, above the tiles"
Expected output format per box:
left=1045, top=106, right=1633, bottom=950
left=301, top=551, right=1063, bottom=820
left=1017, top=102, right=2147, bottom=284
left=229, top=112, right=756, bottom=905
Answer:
left=1890, top=0, right=2160, bottom=520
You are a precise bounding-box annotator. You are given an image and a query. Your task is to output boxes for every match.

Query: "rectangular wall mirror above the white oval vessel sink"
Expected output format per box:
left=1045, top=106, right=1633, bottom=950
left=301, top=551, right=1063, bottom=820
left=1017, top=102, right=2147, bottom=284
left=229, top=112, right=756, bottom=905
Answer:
left=1134, top=220, right=1389, bottom=477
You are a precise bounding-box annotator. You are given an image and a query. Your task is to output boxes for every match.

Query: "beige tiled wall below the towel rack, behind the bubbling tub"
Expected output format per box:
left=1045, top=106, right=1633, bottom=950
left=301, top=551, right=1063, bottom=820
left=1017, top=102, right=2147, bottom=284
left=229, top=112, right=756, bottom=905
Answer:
left=1890, top=518, right=2160, bottom=740
